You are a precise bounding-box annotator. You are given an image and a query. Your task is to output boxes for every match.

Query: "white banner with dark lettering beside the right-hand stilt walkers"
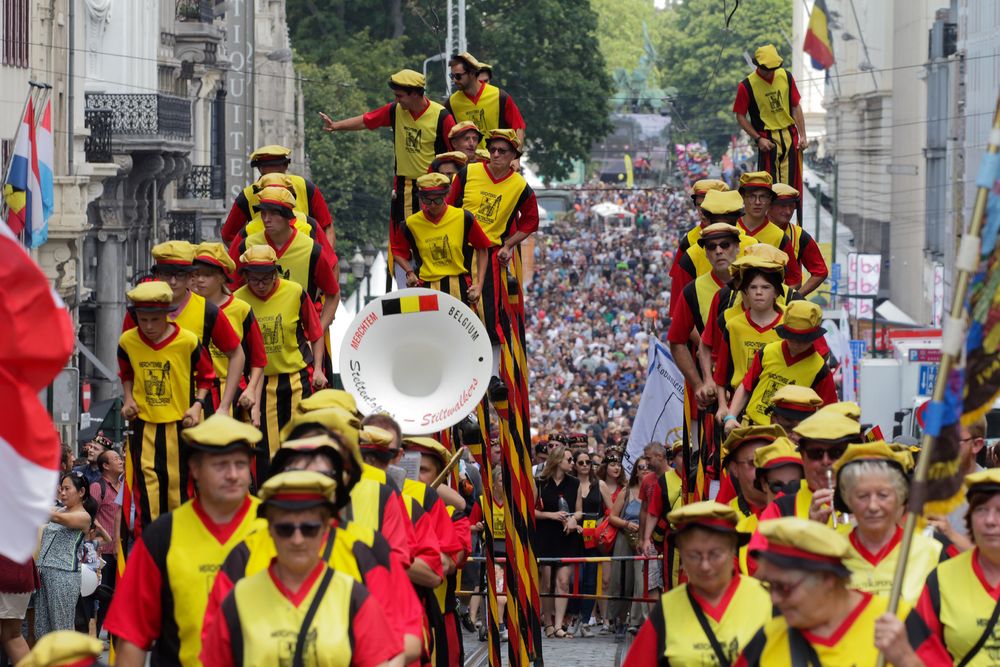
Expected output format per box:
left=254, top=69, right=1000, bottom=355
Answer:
left=622, top=338, right=684, bottom=475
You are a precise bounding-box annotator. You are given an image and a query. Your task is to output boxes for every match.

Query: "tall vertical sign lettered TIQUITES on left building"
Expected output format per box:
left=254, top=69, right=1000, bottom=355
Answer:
left=225, top=0, right=255, bottom=197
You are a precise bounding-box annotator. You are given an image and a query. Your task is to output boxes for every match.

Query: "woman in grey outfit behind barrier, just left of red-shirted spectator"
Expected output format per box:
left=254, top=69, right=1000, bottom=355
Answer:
left=608, top=456, right=653, bottom=632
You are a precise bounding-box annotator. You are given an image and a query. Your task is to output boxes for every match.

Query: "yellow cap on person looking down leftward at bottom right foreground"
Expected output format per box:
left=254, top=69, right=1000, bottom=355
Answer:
left=750, top=517, right=851, bottom=578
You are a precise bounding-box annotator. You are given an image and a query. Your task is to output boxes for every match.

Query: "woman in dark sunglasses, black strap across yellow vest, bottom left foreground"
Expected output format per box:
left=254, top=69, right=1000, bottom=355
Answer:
left=201, top=470, right=403, bottom=667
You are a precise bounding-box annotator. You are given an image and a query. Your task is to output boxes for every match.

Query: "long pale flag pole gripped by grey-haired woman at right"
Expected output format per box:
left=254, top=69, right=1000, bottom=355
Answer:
left=878, top=92, right=1000, bottom=667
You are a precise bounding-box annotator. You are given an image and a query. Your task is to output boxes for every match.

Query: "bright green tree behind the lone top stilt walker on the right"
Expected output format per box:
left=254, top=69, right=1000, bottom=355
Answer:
left=654, top=0, right=792, bottom=157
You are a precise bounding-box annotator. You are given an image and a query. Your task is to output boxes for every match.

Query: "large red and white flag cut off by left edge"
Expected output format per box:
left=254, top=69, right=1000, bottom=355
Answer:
left=0, top=220, right=74, bottom=563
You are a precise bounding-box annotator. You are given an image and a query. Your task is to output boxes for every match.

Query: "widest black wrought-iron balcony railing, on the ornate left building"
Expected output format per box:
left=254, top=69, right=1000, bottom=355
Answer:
left=87, top=93, right=191, bottom=139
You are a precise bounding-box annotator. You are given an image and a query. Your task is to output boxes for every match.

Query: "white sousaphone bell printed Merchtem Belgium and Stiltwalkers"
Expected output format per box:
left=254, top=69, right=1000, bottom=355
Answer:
left=340, top=287, right=492, bottom=435
